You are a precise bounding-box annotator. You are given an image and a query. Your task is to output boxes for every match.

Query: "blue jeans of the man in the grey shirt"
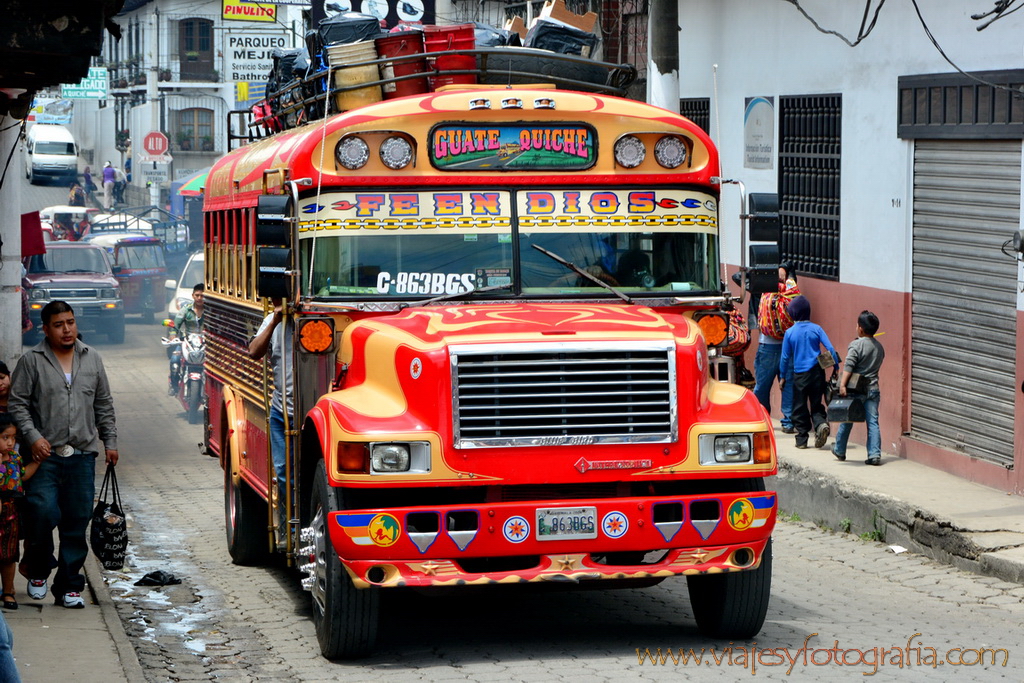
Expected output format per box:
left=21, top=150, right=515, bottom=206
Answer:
left=22, top=455, right=96, bottom=597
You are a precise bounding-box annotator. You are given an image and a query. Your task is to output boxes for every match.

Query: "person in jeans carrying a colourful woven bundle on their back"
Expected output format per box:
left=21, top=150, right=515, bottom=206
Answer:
left=754, top=263, right=800, bottom=434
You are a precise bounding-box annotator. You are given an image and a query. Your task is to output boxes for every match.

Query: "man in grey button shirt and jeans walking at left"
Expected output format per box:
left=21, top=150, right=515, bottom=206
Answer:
left=9, top=300, right=118, bottom=608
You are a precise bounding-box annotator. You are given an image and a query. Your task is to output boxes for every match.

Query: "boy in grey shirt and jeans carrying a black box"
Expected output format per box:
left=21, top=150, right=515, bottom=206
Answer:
left=833, top=310, right=886, bottom=465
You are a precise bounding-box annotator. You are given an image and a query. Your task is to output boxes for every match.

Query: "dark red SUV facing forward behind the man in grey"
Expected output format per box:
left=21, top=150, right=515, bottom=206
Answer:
left=23, top=242, right=125, bottom=344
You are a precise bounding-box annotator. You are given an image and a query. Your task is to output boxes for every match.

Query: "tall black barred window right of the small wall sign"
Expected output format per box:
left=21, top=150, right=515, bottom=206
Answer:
left=778, top=95, right=843, bottom=280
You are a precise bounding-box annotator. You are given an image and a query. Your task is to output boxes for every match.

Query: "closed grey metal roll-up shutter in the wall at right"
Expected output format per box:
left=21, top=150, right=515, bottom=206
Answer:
left=910, top=140, right=1021, bottom=466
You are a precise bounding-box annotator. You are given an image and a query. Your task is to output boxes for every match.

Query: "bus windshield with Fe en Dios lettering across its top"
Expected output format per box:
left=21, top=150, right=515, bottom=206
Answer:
left=299, top=190, right=721, bottom=298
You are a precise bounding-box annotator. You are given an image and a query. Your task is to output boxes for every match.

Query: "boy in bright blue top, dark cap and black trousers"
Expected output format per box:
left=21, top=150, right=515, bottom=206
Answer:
left=778, top=296, right=839, bottom=449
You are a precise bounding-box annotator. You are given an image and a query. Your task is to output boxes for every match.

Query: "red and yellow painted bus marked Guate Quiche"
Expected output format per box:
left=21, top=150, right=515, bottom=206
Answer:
left=204, top=49, right=777, bottom=657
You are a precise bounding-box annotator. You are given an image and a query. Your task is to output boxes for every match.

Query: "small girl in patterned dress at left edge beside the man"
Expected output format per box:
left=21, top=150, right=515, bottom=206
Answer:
left=0, top=413, right=39, bottom=609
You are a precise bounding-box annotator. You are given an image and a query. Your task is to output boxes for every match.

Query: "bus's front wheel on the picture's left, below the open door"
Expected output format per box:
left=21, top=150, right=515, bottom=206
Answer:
left=309, top=461, right=380, bottom=659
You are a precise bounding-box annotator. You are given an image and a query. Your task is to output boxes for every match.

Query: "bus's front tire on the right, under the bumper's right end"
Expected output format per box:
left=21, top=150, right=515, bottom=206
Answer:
left=686, top=539, right=772, bottom=640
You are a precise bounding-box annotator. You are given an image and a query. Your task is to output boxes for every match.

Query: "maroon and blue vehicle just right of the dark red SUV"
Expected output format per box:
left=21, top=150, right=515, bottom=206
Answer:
left=85, top=232, right=167, bottom=323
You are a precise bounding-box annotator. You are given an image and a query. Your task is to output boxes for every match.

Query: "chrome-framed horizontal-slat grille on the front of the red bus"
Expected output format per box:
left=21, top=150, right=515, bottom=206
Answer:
left=450, top=341, right=677, bottom=449
